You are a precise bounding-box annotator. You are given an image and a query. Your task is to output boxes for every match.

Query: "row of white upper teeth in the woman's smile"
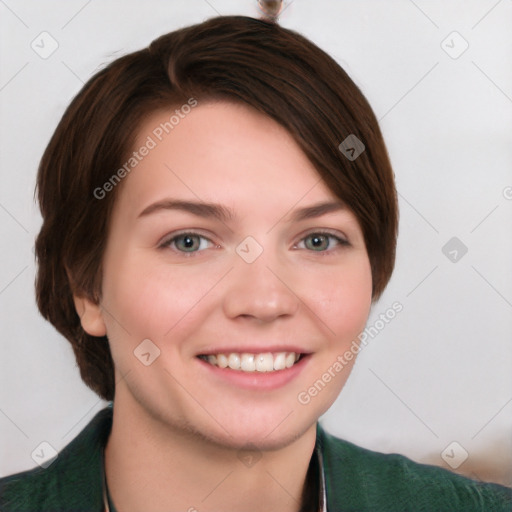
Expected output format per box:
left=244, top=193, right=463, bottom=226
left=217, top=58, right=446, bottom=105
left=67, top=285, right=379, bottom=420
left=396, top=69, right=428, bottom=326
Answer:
left=200, top=352, right=300, bottom=372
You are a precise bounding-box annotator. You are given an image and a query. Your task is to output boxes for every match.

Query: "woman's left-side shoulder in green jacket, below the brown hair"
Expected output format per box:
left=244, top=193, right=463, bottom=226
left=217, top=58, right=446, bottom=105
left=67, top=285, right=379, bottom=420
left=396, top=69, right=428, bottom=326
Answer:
left=0, top=406, right=112, bottom=512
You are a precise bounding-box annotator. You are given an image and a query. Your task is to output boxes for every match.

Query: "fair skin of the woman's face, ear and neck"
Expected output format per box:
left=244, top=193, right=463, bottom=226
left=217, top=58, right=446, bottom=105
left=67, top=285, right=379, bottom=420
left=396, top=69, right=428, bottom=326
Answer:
left=75, top=102, right=372, bottom=512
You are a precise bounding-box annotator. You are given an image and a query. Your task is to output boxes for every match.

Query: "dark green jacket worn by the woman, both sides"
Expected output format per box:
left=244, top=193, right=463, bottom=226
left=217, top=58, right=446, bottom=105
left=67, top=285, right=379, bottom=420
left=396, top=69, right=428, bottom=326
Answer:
left=0, top=406, right=512, bottom=512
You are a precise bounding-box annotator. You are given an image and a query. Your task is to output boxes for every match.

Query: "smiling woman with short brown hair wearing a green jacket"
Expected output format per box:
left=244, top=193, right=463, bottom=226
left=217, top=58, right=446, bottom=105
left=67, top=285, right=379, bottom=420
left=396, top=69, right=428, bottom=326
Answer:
left=0, top=17, right=511, bottom=512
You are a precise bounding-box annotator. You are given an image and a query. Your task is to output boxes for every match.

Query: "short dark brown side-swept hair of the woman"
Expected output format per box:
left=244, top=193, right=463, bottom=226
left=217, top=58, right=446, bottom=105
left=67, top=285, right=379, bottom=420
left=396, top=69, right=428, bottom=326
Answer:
left=36, top=16, right=398, bottom=400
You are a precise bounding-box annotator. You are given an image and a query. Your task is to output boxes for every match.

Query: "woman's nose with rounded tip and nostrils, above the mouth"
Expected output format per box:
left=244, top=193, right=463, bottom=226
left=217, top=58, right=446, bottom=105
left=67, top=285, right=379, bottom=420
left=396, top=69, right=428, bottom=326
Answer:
left=223, top=252, right=300, bottom=323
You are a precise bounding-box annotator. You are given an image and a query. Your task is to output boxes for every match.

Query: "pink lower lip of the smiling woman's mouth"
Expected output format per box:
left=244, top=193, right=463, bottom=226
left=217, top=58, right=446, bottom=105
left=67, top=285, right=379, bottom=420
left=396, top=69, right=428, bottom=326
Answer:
left=196, top=354, right=311, bottom=391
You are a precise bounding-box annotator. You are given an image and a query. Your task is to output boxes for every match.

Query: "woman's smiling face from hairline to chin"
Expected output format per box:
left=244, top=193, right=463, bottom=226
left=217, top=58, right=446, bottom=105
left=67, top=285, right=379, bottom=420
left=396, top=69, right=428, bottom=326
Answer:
left=82, top=102, right=372, bottom=447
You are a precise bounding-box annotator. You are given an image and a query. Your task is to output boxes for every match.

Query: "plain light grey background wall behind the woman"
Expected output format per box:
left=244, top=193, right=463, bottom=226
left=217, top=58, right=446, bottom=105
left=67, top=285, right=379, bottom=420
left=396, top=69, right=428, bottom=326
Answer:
left=0, top=0, right=512, bottom=485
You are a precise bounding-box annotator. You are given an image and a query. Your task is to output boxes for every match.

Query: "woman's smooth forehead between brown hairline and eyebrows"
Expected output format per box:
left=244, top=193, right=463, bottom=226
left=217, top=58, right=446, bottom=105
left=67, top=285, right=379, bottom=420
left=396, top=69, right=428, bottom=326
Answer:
left=116, top=102, right=336, bottom=216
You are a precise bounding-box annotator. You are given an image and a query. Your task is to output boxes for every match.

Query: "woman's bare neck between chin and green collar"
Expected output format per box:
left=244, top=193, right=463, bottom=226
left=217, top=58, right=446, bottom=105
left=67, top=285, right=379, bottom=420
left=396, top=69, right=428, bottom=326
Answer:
left=105, top=396, right=316, bottom=512
